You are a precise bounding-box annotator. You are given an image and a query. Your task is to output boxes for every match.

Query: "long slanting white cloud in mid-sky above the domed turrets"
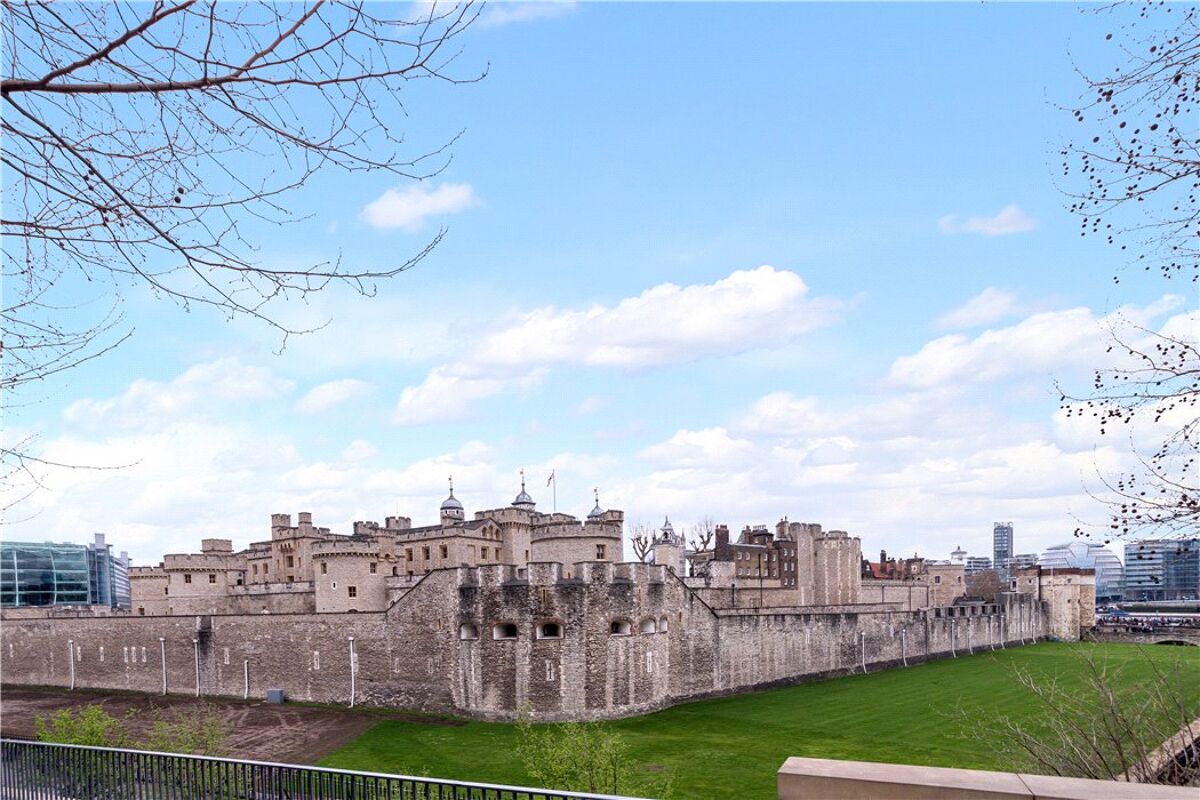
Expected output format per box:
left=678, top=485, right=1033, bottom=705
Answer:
left=395, top=266, right=844, bottom=425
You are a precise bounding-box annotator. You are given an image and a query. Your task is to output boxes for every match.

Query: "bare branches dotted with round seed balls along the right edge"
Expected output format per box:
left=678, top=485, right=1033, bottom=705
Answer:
left=1060, top=0, right=1200, bottom=540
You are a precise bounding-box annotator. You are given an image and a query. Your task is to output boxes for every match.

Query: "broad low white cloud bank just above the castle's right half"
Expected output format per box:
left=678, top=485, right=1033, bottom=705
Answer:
left=619, top=392, right=1130, bottom=558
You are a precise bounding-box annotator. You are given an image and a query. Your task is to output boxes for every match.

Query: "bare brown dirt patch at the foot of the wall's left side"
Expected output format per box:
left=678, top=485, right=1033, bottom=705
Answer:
left=0, top=686, right=461, bottom=764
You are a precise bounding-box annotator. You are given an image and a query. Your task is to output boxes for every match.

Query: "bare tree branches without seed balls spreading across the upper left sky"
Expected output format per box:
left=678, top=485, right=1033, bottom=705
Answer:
left=0, top=0, right=481, bottom=489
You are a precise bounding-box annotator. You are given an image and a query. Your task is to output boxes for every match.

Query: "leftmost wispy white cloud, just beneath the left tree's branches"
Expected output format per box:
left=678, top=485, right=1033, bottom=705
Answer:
left=62, top=357, right=294, bottom=428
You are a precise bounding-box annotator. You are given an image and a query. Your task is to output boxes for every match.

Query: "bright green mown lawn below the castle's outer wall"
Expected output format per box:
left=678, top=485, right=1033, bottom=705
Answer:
left=322, top=643, right=1200, bottom=798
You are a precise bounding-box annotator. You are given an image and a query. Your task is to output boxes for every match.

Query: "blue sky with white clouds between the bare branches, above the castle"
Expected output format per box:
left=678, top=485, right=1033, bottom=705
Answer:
left=5, top=4, right=1195, bottom=563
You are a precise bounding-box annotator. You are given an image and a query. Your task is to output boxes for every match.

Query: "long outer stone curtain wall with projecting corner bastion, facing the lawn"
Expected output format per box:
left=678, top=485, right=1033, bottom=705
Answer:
left=0, top=563, right=1048, bottom=720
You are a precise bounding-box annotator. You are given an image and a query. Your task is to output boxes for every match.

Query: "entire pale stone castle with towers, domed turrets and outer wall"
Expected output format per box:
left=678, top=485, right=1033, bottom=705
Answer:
left=0, top=482, right=1094, bottom=720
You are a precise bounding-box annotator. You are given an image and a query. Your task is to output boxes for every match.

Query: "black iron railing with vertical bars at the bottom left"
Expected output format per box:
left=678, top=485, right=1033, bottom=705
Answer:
left=0, top=739, right=648, bottom=800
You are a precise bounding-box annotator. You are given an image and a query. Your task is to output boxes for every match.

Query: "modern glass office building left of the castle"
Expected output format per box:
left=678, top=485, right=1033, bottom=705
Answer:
left=0, top=534, right=131, bottom=608
